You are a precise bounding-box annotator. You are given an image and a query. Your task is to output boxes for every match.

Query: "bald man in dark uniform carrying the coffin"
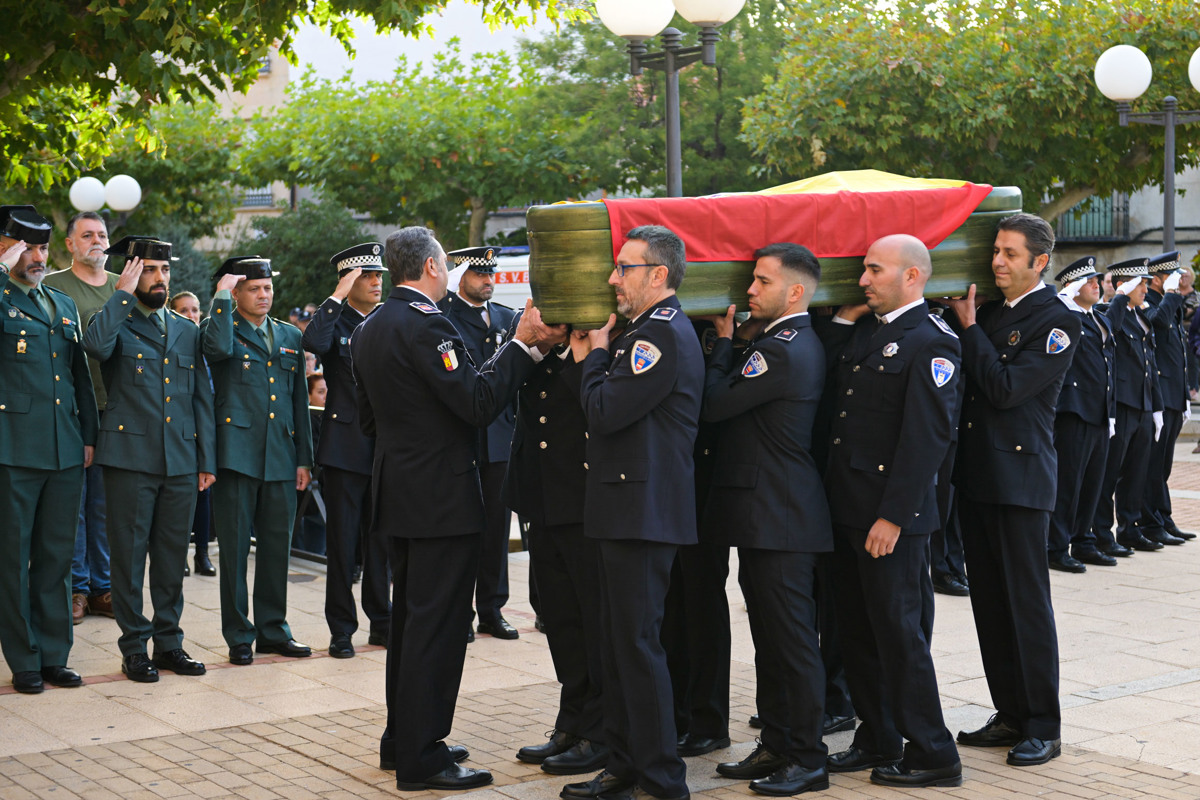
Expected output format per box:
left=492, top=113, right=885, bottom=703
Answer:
left=820, top=234, right=973, bottom=787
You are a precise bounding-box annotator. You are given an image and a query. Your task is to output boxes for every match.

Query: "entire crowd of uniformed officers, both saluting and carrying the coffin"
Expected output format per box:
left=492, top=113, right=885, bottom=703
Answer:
left=0, top=200, right=1193, bottom=800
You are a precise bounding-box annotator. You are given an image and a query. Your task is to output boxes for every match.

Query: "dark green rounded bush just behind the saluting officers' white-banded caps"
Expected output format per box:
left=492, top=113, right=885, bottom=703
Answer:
left=226, top=200, right=371, bottom=319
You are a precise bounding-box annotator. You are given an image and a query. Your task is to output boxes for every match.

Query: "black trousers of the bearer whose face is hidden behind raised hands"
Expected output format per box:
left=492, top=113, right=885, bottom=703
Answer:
left=528, top=523, right=604, bottom=742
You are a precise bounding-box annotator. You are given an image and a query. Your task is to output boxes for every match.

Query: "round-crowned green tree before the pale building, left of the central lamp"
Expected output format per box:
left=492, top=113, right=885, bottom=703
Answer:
left=241, top=40, right=592, bottom=245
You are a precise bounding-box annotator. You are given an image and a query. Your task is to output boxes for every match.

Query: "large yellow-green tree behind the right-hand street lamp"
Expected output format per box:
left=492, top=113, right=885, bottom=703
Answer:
left=743, top=0, right=1200, bottom=218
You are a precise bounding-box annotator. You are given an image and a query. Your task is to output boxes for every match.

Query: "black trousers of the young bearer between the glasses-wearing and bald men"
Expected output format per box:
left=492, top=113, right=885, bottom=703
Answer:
left=738, top=547, right=828, bottom=769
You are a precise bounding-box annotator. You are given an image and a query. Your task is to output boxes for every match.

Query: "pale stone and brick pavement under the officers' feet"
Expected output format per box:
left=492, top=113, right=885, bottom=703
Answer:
left=7, top=443, right=1200, bottom=800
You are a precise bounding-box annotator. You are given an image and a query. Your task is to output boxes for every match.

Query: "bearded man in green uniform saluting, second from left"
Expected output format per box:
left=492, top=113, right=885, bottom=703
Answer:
left=83, top=236, right=216, bottom=682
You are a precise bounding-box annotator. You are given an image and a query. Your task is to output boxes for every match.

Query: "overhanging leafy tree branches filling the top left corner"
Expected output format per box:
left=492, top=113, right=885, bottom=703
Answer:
left=0, top=0, right=581, bottom=188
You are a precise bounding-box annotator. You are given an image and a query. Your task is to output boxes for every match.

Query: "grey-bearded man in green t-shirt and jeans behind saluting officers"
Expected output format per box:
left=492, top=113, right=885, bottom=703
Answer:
left=44, top=211, right=119, bottom=625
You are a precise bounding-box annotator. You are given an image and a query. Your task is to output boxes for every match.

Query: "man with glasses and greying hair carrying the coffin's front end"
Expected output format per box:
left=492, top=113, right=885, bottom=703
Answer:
left=563, top=225, right=704, bottom=800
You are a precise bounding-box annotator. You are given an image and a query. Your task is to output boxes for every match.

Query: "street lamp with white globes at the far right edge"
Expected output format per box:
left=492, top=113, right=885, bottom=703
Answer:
left=1096, top=44, right=1200, bottom=251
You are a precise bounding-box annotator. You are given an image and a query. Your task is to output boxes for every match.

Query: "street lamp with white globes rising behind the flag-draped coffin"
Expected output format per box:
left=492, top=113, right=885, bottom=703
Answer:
left=596, top=0, right=745, bottom=197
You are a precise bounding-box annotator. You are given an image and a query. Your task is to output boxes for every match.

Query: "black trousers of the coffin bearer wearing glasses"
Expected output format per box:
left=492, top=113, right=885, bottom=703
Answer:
left=598, top=540, right=688, bottom=798
